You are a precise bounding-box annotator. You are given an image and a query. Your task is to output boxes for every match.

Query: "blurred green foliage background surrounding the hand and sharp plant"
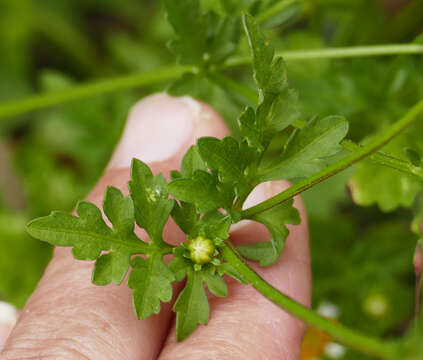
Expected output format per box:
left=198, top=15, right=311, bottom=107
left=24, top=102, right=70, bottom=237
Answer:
left=0, top=0, right=423, bottom=359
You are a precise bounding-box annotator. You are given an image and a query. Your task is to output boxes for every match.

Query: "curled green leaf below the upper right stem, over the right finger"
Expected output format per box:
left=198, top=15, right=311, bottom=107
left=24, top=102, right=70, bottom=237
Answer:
left=237, top=200, right=300, bottom=266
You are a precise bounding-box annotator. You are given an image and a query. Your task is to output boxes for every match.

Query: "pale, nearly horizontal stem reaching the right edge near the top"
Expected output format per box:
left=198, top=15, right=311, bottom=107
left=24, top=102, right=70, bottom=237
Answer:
left=225, top=44, right=423, bottom=67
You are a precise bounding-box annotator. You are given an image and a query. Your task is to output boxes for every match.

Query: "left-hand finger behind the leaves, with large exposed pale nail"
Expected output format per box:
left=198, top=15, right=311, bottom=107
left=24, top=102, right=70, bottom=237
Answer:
left=2, top=94, right=227, bottom=360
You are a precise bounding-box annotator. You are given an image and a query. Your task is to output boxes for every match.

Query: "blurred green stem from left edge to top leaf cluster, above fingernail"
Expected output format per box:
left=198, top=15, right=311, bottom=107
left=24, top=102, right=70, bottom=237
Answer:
left=0, top=66, right=192, bottom=119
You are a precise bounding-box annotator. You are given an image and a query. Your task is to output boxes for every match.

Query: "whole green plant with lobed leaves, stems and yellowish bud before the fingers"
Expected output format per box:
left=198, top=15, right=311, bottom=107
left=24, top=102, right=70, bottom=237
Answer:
left=0, top=0, right=423, bottom=357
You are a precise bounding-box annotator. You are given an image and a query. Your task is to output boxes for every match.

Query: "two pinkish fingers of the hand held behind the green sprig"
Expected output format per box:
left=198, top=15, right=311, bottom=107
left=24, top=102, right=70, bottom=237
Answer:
left=0, top=94, right=311, bottom=360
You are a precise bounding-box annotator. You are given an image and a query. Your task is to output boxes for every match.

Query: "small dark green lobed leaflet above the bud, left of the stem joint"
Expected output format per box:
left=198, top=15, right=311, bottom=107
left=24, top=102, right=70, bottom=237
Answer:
left=168, top=170, right=222, bottom=212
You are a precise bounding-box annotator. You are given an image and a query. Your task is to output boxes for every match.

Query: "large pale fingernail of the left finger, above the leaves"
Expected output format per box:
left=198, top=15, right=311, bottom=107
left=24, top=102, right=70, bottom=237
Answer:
left=108, top=93, right=202, bottom=169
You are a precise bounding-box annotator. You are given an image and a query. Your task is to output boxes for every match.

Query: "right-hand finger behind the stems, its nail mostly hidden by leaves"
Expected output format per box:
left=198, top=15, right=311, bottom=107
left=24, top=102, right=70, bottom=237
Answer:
left=159, top=181, right=311, bottom=360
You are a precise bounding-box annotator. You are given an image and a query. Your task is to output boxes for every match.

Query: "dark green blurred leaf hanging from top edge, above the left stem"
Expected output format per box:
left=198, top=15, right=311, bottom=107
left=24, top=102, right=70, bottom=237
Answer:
left=164, top=0, right=208, bottom=66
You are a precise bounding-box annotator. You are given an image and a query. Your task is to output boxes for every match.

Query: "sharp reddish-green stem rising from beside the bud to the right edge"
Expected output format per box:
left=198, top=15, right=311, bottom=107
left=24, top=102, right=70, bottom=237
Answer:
left=241, top=100, right=423, bottom=219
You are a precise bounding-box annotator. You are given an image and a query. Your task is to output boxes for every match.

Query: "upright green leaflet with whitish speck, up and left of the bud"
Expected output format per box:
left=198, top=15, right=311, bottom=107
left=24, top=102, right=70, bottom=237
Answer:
left=129, top=159, right=174, bottom=246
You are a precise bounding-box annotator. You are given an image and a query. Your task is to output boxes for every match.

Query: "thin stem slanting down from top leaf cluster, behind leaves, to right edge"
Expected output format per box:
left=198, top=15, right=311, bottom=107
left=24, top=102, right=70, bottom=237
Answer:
left=210, top=73, right=423, bottom=181
